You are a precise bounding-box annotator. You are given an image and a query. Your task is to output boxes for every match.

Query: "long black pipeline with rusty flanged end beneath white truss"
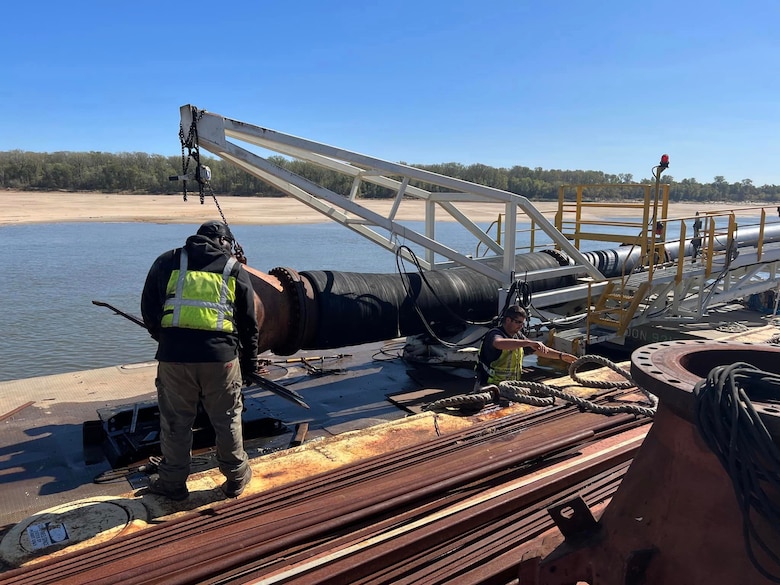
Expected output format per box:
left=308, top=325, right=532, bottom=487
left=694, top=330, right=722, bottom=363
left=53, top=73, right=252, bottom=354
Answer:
left=248, top=225, right=780, bottom=355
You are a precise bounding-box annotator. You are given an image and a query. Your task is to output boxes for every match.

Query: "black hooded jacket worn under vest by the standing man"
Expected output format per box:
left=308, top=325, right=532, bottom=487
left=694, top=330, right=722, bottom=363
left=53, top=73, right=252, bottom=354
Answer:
left=141, top=235, right=259, bottom=363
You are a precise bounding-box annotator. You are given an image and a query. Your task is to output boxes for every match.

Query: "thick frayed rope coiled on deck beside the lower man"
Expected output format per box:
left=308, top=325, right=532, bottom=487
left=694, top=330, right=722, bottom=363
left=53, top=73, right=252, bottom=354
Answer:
left=425, top=355, right=658, bottom=417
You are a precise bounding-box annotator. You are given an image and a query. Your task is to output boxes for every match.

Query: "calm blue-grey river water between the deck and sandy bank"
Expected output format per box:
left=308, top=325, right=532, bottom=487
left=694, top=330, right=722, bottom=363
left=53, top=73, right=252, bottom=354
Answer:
left=0, top=222, right=487, bottom=381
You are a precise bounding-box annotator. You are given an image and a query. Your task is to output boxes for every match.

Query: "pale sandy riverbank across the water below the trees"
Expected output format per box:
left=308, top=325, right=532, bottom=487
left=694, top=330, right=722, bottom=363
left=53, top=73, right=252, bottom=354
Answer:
left=0, top=191, right=748, bottom=226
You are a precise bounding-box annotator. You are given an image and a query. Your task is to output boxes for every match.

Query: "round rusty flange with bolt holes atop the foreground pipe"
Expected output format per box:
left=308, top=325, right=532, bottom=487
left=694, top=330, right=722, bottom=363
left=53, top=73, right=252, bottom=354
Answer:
left=631, top=340, right=780, bottom=433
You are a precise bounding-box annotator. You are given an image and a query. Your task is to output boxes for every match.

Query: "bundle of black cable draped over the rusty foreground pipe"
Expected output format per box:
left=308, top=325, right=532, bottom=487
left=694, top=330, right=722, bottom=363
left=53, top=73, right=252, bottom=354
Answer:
left=693, top=362, right=780, bottom=583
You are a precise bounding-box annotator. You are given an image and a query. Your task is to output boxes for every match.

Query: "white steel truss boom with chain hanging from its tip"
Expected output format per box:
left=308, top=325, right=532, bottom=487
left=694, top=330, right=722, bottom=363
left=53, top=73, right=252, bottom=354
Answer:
left=181, top=105, right=603, bottom=286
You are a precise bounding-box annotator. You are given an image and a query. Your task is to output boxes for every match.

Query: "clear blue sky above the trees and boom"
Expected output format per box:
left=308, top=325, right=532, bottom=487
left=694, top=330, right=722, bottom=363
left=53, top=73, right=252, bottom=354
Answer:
left=0, top=0, right=780, bottom=186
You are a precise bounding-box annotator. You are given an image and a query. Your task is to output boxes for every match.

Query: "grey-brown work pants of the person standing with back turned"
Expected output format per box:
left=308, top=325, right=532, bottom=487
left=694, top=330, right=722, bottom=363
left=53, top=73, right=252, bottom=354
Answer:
left=155, top=358, right=249, bottom=487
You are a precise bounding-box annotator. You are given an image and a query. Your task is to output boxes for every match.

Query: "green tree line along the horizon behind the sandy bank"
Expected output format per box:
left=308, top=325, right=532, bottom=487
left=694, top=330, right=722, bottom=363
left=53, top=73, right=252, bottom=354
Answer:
left=0, top=150, right=780, bottom=204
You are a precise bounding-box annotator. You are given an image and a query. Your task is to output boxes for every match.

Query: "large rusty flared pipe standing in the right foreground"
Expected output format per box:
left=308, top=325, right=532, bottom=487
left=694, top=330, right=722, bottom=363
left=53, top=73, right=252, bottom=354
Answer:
left=522, top=341, right=780, bottom=585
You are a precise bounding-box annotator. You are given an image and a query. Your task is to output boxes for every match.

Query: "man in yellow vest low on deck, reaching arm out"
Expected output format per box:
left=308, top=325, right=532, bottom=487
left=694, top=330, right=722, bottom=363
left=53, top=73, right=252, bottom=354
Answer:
left=477, top=305, right=577, bottom=388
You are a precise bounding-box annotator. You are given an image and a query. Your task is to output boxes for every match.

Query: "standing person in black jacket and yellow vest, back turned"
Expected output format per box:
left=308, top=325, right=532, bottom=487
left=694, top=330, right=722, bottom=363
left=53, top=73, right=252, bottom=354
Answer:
left=141, top=221, right=259, bottom=500
